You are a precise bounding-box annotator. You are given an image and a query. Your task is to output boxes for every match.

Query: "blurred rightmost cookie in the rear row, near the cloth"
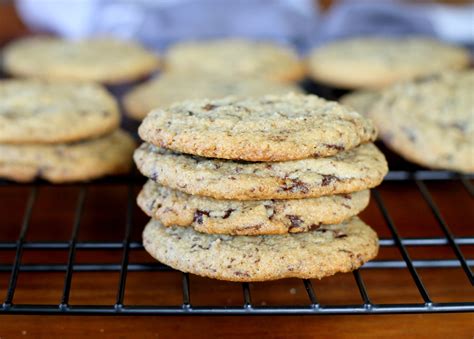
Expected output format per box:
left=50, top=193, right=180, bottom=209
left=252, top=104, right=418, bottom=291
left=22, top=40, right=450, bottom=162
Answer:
left=308, top=37, right=469, bottom=88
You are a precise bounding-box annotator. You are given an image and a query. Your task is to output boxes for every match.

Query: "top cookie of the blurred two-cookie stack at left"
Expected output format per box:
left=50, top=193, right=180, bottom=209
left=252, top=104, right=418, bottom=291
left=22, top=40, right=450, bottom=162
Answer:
left=0, top=80, right=120, bottom=143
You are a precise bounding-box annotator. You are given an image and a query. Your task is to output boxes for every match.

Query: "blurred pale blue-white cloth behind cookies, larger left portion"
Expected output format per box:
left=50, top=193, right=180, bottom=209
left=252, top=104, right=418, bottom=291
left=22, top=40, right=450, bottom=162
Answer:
left=17, top=0, right=318, bottom=48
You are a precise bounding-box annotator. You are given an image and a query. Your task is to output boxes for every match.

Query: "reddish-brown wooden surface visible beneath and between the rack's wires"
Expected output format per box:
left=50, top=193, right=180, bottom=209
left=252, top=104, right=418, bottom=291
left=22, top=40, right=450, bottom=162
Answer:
left=0, top=4, right=474, bottom=339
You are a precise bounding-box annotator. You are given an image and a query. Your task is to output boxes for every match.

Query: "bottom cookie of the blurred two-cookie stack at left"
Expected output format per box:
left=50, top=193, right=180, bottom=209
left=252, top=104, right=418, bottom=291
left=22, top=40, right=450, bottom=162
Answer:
left=0, top=130, right=135, bottom=183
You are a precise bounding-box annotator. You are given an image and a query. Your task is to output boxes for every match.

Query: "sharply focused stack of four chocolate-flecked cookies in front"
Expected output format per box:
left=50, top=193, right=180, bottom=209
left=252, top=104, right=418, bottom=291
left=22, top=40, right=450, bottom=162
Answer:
left=134, top=94, right=387, bottom=281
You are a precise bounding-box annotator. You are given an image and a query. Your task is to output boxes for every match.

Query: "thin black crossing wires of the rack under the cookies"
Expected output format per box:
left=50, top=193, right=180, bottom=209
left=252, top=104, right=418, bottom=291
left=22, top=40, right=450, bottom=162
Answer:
left=0, top=171, right=474, bottom=315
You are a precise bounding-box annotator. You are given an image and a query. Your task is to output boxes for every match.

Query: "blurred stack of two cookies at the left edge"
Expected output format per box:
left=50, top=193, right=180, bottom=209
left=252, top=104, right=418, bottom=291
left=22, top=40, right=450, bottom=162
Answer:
left=0, top=80, right=135, bottom=183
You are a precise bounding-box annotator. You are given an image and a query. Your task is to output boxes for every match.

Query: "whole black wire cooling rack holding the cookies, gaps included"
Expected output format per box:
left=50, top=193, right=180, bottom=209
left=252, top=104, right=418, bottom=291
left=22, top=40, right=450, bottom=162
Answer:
left=0, top=78, right=474, bottom=315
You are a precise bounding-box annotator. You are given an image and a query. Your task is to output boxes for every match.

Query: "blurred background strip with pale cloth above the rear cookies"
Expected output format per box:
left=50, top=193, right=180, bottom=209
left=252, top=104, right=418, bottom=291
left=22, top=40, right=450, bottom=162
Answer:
left=0, top=0, right=474, bottom=52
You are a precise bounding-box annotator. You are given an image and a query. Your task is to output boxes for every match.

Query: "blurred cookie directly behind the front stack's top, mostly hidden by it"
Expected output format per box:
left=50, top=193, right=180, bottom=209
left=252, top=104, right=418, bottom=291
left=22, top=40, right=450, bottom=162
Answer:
left=124, top=72, right=302, bottom=120
